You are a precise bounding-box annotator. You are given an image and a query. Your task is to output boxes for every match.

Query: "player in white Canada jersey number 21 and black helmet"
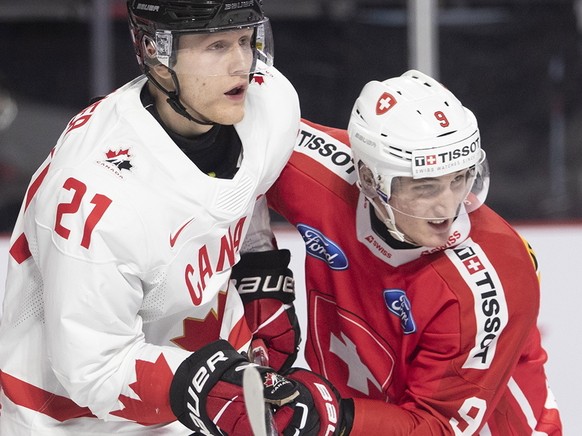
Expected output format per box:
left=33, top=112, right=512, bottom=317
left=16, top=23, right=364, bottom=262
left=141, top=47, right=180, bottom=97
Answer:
left=0, top=0, right=320, bottom=436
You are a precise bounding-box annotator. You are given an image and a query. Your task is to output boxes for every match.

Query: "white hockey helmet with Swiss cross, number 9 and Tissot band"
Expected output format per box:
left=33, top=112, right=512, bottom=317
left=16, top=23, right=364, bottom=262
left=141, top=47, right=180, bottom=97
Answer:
left=348, top=70, right=489, bottom=240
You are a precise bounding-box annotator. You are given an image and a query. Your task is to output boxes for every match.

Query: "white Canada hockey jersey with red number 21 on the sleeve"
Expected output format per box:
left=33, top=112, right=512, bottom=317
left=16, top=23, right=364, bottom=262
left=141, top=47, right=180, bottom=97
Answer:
left=0, top=69, right=299, bottom=436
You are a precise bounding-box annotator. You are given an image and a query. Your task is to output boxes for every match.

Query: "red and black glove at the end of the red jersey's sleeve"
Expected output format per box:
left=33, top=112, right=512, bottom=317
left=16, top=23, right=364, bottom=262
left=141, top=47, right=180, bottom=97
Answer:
left=275, top=368, right=354, bottom=436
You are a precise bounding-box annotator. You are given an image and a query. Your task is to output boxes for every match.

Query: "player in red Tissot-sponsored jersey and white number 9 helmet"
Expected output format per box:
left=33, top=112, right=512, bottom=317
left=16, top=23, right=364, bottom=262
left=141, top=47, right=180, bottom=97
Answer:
left=243, top=71, right=561, bottom=436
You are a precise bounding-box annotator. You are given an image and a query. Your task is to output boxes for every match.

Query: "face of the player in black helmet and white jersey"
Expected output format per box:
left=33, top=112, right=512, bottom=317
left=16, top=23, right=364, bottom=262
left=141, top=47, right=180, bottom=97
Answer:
left=173, top=29, right=253, bottom=125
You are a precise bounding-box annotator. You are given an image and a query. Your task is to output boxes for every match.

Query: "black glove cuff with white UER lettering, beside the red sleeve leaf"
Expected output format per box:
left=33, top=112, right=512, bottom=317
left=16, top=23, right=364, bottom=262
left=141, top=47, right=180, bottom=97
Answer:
left=170, top=339, right=246, bottom=434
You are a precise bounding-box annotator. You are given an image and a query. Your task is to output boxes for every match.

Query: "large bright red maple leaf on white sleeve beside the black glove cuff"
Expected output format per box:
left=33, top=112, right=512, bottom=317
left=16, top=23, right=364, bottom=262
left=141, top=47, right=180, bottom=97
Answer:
left=111, top=353, right=176, bottom=425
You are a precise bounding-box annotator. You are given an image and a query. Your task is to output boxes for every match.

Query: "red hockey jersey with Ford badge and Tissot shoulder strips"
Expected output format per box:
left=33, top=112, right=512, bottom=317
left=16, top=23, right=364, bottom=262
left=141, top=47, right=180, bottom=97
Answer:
left=268, top=122, right=561, bottom=435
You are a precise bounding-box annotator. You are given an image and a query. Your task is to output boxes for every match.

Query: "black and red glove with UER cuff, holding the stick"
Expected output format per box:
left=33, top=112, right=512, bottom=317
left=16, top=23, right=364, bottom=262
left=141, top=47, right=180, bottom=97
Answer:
left=170, top=340, right=298, bottom=435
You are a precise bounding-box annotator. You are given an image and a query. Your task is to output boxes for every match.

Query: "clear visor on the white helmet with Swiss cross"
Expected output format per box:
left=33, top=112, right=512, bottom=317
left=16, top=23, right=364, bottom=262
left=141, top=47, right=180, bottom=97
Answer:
left=379, top=154, right=489, bottom=221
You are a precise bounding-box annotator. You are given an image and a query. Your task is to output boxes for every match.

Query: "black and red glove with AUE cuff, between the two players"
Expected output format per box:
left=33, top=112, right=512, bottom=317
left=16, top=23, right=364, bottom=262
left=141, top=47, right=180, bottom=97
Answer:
left=231, top=250, right=301, bottom=371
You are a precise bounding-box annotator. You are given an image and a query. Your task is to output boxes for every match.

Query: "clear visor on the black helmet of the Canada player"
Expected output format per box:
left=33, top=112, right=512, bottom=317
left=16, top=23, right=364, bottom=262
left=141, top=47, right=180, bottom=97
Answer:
left=144, top=19, right=273, bottom=77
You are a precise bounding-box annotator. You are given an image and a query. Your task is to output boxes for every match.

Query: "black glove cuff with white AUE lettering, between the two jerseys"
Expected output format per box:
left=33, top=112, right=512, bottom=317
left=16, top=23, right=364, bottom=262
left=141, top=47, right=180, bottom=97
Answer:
left=230, top=250, right=295, bottom=304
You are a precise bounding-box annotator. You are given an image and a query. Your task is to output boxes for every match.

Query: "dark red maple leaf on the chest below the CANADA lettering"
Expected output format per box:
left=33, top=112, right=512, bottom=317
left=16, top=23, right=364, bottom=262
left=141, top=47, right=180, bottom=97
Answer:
left=172, top=292, right=226, bottom=351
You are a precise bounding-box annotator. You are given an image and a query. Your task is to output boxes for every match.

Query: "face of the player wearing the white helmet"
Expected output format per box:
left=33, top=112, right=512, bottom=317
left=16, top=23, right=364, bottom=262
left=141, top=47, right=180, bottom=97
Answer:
left=388, top=169, right=474, bottom=247
